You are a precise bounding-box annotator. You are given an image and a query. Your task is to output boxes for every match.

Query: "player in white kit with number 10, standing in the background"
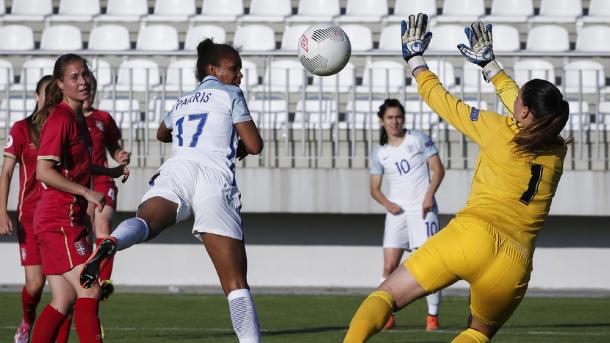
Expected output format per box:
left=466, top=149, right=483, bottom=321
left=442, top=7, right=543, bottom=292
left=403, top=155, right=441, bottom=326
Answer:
left=369, top=99, right=445, bottom=331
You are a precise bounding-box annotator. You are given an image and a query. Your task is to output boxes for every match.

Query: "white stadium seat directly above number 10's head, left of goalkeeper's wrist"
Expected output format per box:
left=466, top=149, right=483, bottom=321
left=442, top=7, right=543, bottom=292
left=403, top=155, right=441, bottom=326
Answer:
left=356, top=60, right=405, bottom=96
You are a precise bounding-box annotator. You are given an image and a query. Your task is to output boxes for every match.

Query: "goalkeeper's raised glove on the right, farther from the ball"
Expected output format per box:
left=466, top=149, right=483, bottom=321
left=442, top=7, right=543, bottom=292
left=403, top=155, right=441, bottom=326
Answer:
left=457, top=21, right=502, bottom=82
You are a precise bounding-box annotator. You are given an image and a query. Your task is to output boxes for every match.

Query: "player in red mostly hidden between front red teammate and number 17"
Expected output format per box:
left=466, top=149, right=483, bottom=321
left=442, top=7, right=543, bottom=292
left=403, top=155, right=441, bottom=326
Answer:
left=83, top=76, right=131, bottom=299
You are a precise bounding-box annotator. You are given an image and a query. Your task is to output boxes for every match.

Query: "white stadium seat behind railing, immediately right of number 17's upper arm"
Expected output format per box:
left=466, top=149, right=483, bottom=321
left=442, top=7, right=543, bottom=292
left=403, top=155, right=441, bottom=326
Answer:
left=248, top=97, right=288, bottom=129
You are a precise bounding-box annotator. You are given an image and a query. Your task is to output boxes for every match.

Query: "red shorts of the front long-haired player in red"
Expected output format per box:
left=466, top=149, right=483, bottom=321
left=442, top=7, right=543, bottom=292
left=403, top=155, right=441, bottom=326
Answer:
left=36, top=226, right=91, bottom=275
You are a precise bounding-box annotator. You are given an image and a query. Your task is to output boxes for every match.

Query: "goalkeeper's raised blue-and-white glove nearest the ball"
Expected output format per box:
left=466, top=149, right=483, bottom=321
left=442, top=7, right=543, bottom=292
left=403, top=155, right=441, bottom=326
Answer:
left=400, top=13, right=432, bottom=62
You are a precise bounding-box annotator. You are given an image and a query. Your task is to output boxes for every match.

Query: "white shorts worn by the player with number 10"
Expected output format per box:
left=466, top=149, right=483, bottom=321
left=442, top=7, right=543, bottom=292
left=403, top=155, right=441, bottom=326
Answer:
left=383, top=210, right=440, bottom=250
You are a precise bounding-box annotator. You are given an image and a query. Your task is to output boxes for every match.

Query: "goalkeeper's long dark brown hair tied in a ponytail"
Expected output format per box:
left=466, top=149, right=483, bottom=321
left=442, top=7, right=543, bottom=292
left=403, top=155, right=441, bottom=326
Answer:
left=513, top=79, right=573, bottom=156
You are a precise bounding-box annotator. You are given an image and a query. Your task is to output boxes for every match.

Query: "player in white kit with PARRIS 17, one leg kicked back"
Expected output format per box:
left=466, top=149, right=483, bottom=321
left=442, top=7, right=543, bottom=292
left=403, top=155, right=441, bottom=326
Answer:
left=81, top=39, right=263, bottom=343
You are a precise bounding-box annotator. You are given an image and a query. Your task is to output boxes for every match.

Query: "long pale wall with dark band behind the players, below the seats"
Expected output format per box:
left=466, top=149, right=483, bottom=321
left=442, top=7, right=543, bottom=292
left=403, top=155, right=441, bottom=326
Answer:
left=0, top=168, right=610, bottom=290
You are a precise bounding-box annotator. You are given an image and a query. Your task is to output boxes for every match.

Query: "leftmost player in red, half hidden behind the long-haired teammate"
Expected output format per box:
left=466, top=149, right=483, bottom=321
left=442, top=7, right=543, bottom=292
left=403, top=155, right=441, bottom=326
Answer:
left=0, top=75, right=57, bottom=343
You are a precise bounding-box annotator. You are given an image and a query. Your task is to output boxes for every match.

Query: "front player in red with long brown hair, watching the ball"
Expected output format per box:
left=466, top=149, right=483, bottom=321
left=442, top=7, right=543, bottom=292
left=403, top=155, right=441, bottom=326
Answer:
left=32, top=54, right=123, bottom=343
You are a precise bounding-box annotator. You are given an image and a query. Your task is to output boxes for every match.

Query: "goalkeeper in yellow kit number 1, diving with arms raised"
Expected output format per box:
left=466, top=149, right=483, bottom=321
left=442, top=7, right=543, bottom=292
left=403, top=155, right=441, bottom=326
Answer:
left=344, top=14, right=570, bottom=343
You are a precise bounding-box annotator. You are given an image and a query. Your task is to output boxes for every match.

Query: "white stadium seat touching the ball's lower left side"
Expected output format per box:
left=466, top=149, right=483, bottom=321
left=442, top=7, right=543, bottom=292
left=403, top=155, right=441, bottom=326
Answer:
left=256, top=58, right=306, bottom=92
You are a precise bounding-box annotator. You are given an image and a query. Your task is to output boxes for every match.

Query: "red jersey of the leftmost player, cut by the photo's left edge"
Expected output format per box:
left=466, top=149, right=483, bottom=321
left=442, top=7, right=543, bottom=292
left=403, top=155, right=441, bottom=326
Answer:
left=4, top=119, right=40, bottom=223
